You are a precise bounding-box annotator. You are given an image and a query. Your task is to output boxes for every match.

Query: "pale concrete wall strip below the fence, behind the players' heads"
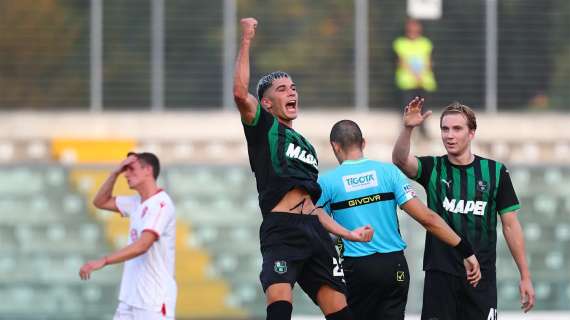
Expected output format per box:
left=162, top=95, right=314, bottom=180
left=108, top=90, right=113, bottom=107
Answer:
left=0, top=110, right=570, bottom=140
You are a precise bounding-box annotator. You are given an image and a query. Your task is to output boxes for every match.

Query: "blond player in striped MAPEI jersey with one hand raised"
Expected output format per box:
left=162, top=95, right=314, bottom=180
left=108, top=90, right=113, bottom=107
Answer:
left=392, top=97, right=535, bottom=320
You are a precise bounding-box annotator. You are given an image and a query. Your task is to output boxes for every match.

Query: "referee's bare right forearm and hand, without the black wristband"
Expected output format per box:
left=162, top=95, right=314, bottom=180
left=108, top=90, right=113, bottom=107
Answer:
left=401, top=198, right=481, bottom=287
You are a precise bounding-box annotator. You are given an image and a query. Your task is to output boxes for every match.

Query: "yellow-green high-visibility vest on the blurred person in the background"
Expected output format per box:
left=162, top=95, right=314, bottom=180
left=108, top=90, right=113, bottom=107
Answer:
left=394, top=37, right=437, bottom=91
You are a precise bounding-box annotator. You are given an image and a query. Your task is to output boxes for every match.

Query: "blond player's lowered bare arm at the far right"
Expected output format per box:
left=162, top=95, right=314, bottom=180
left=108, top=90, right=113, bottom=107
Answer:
left=501, top=212, right=534, bottom=312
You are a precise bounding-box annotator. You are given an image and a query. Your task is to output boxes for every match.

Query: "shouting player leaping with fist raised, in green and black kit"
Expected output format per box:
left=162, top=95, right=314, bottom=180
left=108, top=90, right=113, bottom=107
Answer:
left=233, top=18, right=373, bottom=320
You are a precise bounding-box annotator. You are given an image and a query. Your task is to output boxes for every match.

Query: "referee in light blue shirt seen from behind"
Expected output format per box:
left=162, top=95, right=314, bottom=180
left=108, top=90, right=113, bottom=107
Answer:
left=317, top=120, right=481, bottom=320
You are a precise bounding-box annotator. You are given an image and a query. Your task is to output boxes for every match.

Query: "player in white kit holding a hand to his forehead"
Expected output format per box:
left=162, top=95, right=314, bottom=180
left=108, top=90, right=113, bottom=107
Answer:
left=79, top=152, right=177, bottom=320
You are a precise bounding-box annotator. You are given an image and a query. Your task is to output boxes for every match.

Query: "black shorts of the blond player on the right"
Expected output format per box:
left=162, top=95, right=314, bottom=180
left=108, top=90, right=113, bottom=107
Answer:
left=422, top=270, right=497, bottom=320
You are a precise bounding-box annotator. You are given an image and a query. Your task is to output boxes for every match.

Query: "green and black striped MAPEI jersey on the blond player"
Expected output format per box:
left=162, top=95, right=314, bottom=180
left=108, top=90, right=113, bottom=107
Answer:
left=414, top=156, right=520, bottom=276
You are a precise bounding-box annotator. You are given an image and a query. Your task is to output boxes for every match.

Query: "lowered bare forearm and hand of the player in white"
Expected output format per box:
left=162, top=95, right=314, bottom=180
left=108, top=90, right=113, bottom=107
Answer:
left=79, top=230, right=158, bottom=280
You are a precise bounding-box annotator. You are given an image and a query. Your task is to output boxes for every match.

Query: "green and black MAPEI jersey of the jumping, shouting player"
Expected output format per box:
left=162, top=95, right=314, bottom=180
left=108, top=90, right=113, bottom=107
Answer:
left=242, top=105, right=321, bottom=216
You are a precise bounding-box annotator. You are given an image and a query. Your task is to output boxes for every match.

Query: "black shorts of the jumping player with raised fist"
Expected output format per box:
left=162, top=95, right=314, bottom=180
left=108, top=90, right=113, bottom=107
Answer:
left=259, top=212, right=346, bottom=304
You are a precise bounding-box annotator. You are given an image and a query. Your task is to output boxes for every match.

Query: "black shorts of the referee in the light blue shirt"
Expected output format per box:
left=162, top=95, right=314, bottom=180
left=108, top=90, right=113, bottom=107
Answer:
left=342, top=251, right=410, bottom=320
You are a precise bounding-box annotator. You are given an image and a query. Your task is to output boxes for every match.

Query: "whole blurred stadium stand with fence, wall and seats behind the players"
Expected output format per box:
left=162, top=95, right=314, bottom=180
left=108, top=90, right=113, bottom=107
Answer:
left=0, top=0, right=570, bottom=320
